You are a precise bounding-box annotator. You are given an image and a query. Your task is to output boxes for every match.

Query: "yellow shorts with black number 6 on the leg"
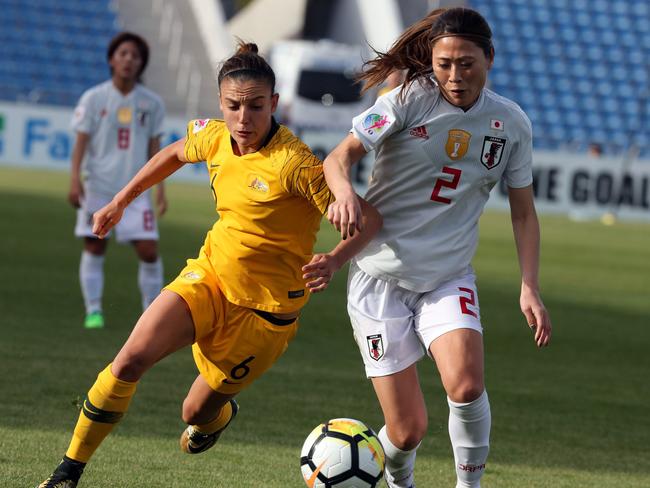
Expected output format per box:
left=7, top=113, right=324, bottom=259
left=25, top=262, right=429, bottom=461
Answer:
left=165, top=252, right=298, bottom=394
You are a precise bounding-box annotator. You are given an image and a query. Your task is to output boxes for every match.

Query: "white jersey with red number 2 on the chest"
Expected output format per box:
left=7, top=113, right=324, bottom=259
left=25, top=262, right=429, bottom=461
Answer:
left=351, top=81, right=533, bottom=292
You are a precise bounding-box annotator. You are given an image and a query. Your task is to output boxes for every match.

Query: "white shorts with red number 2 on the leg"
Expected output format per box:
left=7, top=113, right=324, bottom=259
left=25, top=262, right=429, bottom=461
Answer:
left=348, top=262, right=483, bottom=378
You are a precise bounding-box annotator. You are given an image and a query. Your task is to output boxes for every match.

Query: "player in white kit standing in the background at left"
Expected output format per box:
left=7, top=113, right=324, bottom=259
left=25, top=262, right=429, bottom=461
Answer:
left=68, top=32, right=167, bottom=328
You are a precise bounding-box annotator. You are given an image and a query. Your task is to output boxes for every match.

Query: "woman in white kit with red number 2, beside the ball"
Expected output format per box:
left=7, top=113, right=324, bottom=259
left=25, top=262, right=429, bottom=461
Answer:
left=325, top=8, right=551, bottom=488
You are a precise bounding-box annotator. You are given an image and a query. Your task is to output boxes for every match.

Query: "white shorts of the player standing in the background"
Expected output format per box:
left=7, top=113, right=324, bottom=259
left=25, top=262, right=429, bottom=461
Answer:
left=74, top=192, right=158, bottom=242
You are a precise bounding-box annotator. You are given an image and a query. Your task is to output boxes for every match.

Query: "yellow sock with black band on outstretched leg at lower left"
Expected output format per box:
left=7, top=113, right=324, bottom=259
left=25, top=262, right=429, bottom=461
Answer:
left=66, top=364, right=137, bottom=463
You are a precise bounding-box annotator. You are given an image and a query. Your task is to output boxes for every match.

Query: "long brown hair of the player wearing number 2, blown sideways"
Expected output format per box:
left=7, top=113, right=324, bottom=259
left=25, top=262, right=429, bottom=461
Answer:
left=359, top=7, right=494, bottom=95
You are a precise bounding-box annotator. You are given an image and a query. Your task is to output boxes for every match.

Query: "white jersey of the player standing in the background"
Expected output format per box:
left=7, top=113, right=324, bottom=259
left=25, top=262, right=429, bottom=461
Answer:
left=72, top=80, right=165, bottom=197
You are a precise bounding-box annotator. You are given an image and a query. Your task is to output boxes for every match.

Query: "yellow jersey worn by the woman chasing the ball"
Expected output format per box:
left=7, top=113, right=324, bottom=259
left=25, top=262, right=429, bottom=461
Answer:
left=184, top=119, right=333, bottom=313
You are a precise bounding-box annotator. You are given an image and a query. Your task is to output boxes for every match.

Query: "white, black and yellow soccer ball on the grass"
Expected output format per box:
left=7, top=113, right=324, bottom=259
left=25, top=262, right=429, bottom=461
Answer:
left=300, top=419, right=385, bottom=488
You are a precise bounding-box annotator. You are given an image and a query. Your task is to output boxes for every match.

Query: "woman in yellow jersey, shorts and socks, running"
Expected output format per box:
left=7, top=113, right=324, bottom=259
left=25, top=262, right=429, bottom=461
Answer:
left=39, top=43, right=381, bottom=488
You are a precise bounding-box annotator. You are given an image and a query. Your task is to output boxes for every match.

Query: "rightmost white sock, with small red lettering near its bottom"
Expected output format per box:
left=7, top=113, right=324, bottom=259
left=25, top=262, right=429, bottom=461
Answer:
left=447, top=391, right=492, bottom=488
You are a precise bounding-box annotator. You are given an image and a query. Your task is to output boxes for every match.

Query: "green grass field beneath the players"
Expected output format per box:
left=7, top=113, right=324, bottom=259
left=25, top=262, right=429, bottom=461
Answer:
left=0, top=168, right=650, bottom=488
